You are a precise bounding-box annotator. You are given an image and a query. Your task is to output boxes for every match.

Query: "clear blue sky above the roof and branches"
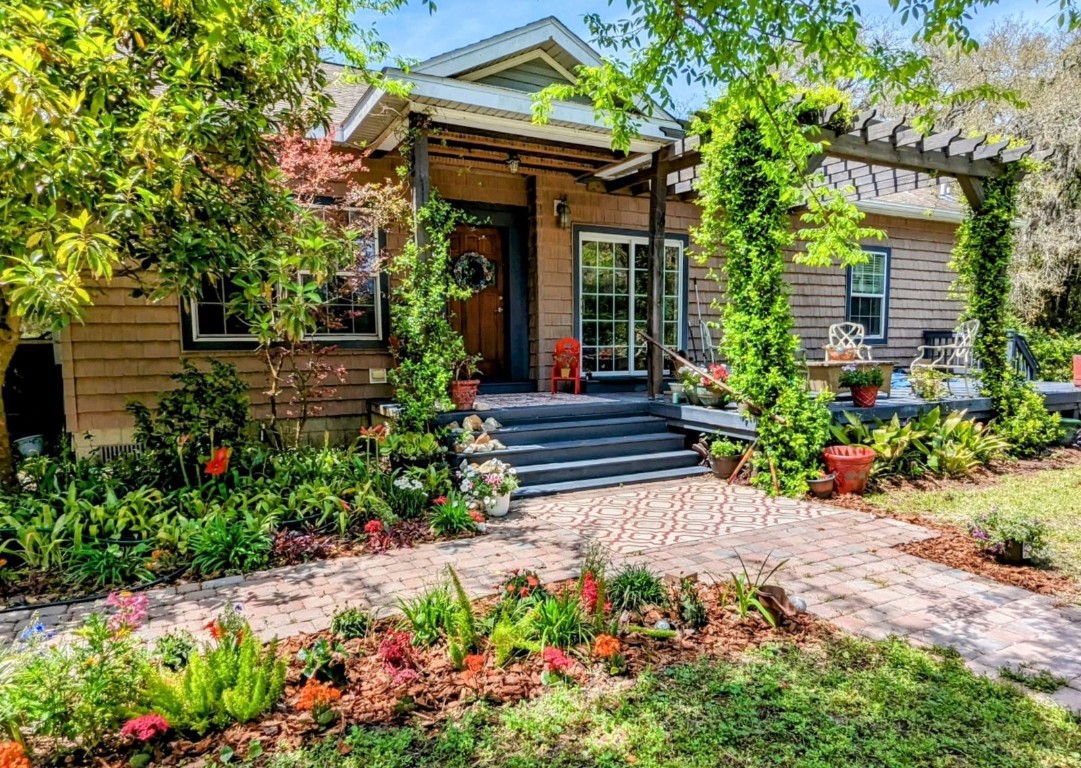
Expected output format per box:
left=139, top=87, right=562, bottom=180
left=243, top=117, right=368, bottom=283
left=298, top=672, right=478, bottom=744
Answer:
left=352, top=0, right=1057, bottom=114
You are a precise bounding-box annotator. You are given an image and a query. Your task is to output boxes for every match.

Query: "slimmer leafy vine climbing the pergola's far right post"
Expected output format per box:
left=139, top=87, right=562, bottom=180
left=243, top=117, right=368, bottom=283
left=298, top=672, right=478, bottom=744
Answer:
left=952, top=165, right=1062, bottom=455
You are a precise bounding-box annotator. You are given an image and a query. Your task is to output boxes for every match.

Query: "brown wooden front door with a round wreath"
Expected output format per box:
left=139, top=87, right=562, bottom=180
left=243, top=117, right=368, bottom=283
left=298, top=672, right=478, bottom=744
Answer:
left=450, top=227, right=508, bottom=380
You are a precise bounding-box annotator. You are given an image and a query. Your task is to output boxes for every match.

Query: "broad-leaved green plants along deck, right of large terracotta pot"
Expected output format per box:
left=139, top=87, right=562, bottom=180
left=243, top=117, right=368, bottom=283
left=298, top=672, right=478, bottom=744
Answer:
left=831, top=406, right=1010, bottom=477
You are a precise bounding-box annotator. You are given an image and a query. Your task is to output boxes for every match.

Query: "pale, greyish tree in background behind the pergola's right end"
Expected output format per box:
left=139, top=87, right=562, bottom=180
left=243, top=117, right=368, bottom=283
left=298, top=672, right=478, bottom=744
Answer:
left=927, top=18, right=1081, bottom=333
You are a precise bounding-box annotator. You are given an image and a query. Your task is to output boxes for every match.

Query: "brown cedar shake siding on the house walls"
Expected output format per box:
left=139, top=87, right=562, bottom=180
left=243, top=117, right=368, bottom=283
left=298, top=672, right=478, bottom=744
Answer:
left=59, top=151, right=960, bottom=450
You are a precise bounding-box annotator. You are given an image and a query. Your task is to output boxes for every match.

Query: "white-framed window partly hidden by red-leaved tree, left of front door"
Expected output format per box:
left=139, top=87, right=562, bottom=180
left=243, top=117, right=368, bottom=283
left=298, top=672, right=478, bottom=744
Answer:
left=183, top=230, right=385, bottom=346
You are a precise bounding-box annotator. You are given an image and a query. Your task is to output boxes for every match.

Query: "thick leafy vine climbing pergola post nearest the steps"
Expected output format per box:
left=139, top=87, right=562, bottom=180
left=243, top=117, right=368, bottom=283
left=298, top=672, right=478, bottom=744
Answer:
left=694, top=101, right=860, bottom=494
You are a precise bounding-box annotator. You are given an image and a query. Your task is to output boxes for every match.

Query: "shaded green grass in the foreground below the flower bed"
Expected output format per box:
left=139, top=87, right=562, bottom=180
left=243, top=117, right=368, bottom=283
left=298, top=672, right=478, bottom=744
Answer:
left=261, top=639, right=1081, bottom=768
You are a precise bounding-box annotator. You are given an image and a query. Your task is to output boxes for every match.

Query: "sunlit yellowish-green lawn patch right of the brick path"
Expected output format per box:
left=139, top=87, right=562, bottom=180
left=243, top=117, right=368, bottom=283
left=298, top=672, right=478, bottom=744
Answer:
left=867, top=466, right=1081, bottom=581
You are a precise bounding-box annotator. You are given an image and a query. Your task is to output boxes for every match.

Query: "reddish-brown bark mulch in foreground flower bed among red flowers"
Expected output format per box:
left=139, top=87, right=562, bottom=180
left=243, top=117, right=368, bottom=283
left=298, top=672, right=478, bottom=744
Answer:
left=139, top=582, right=832, bottom=766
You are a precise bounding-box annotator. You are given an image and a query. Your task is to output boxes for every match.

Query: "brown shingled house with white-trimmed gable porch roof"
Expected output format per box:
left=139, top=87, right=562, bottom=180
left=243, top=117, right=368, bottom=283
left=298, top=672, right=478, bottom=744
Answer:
left=27, top=18, right=962, bottom=456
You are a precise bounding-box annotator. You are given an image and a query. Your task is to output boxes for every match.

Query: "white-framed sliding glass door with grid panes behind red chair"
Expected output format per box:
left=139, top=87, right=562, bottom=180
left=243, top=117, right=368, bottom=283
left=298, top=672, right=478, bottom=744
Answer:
left=577, top=230, right=683, bottom=375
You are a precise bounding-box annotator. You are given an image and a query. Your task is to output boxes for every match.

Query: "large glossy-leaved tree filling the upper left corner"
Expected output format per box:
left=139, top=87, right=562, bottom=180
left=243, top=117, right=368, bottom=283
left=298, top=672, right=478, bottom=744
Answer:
left=0, top=0, right=417, bottom=484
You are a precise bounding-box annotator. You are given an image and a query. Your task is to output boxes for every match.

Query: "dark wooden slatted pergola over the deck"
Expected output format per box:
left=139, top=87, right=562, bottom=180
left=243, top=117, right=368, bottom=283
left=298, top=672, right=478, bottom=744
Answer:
left=578, top=111, right=1053, bottom=397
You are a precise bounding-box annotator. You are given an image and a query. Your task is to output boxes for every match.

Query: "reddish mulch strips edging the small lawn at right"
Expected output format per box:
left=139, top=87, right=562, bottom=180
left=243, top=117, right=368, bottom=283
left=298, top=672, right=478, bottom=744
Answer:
left=830, top=450, right=1081, bottom=603
